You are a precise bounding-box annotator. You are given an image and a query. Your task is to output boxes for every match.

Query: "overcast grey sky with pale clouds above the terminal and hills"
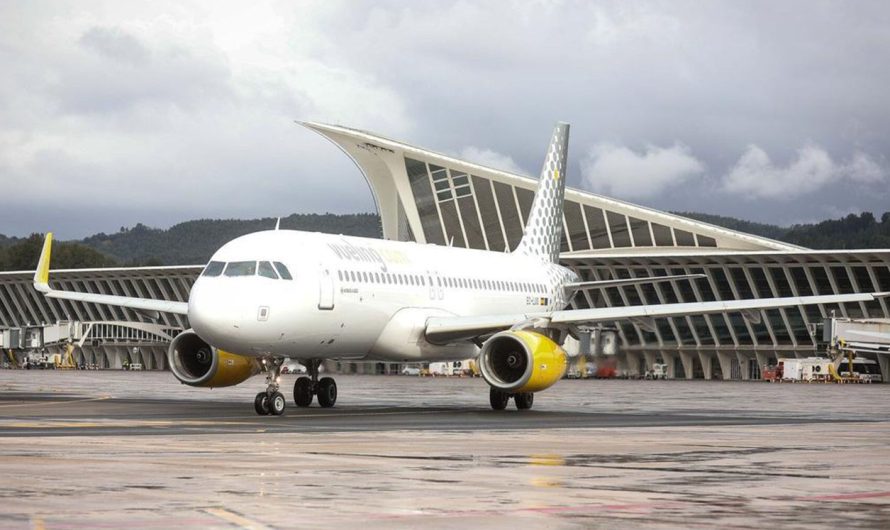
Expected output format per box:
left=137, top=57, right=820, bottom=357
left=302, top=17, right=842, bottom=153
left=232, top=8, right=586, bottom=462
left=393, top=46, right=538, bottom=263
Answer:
left=0, top=0, right=890, bottom=239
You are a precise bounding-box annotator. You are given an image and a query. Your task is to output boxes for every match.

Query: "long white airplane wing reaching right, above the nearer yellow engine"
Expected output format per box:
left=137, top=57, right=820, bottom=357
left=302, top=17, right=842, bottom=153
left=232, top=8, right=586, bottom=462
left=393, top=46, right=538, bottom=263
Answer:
left=426, top=292, right=890, bottom=344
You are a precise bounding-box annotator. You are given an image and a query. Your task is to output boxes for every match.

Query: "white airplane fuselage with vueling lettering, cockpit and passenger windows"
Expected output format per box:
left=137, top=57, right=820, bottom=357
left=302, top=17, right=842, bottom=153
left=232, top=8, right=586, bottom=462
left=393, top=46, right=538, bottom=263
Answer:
left=188, top=230, right=577, bottom=361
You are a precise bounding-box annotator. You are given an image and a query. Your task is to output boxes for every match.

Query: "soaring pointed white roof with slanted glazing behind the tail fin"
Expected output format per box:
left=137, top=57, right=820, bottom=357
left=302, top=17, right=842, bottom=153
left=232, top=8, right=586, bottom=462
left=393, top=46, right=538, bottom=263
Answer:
left=303, top=123, right=801, bottom=253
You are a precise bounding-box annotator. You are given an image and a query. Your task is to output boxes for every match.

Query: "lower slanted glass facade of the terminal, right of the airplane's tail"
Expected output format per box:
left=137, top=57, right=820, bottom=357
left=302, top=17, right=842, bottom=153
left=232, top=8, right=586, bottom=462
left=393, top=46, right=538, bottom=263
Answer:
left=565, top=255, right=890, bottom=355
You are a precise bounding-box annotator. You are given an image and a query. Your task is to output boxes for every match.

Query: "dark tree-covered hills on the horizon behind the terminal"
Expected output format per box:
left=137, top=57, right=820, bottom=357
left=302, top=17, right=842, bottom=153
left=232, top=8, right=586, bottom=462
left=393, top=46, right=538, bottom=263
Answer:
left=0, top=208, right=890, bottom=270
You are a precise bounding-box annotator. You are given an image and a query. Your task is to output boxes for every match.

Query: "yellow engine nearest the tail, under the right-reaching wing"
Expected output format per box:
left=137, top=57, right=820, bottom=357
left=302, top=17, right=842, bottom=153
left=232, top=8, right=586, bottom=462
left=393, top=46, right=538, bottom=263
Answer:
left=479, top=331, right=567, bottom=394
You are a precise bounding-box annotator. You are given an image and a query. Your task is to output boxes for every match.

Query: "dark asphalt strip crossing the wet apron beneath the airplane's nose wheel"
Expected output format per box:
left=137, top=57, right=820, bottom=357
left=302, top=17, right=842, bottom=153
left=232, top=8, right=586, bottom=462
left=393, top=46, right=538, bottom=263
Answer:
left=0, top=393, right=817, bottom=436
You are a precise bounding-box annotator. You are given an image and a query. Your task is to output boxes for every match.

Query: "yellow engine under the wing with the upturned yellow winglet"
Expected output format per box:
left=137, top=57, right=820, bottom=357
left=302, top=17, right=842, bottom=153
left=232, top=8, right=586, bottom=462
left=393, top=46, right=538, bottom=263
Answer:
left=167, top=330, right=261, bottom=388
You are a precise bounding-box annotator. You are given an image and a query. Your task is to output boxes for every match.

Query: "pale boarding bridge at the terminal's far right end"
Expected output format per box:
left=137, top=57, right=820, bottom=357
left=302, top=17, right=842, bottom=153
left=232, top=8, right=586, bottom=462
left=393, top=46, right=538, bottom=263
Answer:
left=823, top=317, right=890, bottom=383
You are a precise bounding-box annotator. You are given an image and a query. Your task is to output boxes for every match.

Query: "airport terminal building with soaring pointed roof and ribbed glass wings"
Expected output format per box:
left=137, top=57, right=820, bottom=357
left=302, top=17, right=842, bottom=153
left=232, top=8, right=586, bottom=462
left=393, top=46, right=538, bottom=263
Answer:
left=0, top=123, right=890, bottom=381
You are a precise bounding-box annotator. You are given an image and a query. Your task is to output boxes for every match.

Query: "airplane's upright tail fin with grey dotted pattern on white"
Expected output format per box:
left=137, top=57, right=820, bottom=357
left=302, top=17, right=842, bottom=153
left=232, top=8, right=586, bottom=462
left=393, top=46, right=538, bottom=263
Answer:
left=514, top=122, right=569, bottom=263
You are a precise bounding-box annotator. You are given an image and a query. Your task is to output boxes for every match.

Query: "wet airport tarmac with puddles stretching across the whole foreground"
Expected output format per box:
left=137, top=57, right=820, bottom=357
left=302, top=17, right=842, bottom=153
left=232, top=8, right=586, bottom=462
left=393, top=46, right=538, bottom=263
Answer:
left=0, top=371, right=890, bottom=529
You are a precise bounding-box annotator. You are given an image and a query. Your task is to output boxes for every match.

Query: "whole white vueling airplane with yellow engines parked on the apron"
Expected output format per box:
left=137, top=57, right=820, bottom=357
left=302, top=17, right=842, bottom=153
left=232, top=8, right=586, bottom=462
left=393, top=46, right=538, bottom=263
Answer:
left=34, top=123, right=890, bottom=415
